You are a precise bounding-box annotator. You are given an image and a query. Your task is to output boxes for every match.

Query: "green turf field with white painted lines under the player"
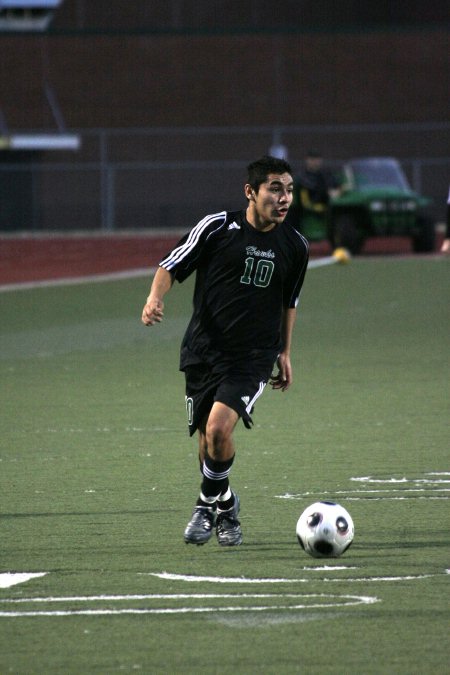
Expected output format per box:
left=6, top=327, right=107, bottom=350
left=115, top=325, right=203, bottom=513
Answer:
left=0, top=258, right=450, bottom=675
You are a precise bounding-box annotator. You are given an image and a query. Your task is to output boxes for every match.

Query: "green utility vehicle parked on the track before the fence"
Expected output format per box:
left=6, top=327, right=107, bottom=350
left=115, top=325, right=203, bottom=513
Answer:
left=299, top=157, right=435, bottom=254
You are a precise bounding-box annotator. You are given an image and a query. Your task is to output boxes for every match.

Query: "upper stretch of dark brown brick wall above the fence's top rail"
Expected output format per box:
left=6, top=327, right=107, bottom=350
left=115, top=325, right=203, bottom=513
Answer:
left=0, top=30, right=450, bottom=129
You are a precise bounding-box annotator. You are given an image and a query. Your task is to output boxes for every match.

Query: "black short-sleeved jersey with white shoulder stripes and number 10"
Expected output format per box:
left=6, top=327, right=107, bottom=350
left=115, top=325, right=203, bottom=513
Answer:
left=160, top=211, right=309, bottom=369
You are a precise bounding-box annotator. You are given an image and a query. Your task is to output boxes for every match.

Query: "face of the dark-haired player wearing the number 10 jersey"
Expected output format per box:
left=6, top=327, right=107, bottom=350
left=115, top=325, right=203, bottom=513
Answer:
left=245, top=173, right=294, bottom=230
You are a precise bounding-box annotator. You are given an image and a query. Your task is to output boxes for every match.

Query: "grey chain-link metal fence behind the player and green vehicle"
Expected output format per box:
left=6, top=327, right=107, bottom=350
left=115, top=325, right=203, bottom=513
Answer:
left=0, top=123, right=450, bottom=232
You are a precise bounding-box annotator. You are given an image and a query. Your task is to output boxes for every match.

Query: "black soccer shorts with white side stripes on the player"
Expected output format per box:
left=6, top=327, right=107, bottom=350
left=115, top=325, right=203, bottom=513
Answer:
left=184, top=353, right=276, bottom=436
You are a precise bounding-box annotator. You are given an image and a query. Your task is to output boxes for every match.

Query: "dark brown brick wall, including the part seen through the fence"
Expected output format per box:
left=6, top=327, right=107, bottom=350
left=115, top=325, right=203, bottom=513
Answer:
left=0, top=28, right=450, bottom=229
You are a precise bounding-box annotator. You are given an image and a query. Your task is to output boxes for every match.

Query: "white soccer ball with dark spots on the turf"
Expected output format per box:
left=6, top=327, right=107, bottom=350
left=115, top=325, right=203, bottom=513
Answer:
left=296, top=502, right=355, bottom=558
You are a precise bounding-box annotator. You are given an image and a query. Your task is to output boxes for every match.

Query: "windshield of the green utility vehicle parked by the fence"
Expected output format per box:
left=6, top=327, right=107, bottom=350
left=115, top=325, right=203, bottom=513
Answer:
left=347, top=159, right=410, bottom=191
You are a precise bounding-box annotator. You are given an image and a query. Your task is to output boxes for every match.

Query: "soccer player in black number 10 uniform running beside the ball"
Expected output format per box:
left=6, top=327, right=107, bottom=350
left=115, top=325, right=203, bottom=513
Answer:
left=142, top=156, right=309, bottom=546
